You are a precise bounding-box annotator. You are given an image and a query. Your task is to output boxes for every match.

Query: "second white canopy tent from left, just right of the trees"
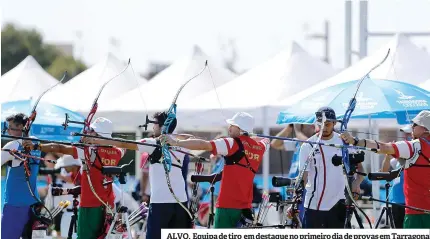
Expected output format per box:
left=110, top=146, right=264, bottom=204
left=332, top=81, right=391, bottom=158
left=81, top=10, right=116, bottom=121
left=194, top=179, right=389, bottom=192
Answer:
left=43, top=53, right=147, bottom=111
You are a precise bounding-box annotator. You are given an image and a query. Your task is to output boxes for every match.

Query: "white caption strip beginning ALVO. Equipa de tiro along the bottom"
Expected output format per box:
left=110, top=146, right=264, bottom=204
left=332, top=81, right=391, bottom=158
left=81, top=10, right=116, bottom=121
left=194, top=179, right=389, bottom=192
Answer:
left=161, top=229, right=430, bottom=239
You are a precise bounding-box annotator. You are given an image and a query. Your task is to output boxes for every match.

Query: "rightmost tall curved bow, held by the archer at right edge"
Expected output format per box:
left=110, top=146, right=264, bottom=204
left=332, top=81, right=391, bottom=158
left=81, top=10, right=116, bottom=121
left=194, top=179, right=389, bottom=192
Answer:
left=340, top=49, right=390, bottom=228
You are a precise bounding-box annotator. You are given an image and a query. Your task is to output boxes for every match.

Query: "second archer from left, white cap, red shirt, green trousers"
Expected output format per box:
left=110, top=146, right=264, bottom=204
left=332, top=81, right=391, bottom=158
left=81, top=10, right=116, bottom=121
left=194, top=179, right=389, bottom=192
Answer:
left=23, top=117, right=125, bottom=238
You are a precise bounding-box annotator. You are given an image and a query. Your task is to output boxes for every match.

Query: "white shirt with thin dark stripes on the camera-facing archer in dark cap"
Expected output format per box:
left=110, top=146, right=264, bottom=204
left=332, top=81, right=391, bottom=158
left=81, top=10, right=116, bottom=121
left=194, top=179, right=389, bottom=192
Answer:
left=299, top=132, right=346, bottom=211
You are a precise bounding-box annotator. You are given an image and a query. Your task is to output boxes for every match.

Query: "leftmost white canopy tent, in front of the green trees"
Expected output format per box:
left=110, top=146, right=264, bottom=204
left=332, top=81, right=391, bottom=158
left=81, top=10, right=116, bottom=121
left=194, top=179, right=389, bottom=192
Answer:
left=0, top=56, right=61, bottom=103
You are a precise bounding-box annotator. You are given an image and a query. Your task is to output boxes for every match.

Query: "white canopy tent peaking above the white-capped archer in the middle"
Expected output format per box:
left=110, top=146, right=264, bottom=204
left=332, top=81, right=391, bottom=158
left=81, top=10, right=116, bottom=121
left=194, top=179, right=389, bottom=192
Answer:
left=182, top=42, right=336, bottom=109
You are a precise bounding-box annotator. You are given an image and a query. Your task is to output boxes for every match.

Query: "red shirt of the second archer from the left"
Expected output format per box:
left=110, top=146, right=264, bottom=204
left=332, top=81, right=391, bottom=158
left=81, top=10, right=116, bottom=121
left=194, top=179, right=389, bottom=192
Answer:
left=73, top=148, right=125, bottom=208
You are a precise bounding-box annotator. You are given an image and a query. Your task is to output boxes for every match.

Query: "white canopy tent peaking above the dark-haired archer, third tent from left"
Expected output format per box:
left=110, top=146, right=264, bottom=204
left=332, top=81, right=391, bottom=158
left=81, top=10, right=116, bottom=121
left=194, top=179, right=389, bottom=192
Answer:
left=99, top=46, right=236, bottom=113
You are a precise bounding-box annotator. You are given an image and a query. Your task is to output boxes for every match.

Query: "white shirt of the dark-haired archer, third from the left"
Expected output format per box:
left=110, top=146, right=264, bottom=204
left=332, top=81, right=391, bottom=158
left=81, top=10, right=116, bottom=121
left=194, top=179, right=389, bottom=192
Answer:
left=137, top=138, right=188, bottom=203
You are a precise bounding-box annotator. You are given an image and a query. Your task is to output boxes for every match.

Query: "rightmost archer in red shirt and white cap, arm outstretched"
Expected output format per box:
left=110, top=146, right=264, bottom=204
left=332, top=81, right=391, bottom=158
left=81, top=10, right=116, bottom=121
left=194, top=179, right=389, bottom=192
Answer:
left=342, top=110, right=430, bottom=228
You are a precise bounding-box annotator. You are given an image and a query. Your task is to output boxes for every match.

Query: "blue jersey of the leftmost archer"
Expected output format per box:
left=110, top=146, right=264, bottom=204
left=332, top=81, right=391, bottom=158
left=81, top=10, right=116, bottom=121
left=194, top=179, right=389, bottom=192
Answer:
left=4, top=144, right=41, bottom=206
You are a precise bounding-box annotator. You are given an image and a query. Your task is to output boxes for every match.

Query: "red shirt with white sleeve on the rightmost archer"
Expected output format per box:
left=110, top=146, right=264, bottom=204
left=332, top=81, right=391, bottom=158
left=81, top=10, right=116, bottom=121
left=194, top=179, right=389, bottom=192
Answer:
left=393, top=137, right=430, bottom=215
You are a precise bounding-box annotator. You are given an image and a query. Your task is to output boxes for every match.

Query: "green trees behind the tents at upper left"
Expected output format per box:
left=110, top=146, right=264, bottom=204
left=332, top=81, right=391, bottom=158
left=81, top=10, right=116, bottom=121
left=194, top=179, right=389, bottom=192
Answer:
left=1, top=23, right=87, bottom=79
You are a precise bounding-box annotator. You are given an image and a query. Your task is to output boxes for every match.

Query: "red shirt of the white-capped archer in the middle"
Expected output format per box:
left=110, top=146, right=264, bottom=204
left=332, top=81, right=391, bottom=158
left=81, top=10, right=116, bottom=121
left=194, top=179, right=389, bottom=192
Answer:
left=211, top=136, right=269, bottom=209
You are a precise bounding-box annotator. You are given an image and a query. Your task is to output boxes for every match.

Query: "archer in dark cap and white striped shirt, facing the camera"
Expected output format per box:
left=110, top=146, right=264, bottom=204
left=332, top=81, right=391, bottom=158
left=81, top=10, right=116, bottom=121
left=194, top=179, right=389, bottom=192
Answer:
left=289, top=107, right=364, bottom=228
